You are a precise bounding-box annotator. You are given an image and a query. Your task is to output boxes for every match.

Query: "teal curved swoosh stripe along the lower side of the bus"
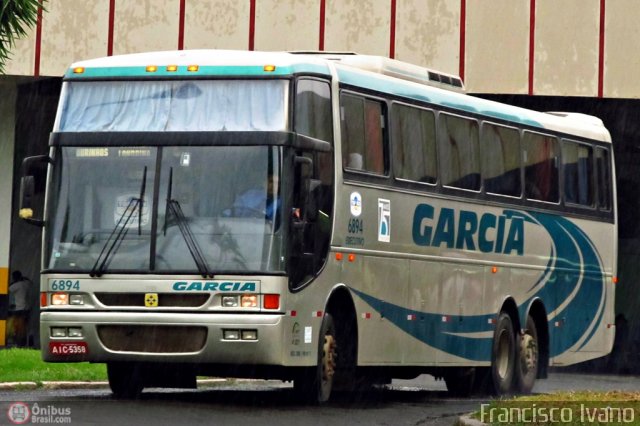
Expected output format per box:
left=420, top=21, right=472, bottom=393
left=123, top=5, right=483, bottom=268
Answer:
left=352, top=212, right=606, bottom=361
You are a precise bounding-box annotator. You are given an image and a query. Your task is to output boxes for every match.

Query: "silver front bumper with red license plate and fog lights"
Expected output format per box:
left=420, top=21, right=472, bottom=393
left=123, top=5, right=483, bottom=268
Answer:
left=40, top=312, right=283, bottom=365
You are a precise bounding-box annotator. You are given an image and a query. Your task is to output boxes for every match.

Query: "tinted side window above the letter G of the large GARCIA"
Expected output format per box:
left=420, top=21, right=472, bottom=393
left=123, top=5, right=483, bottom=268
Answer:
left=391, top=104, right=438, bottom=184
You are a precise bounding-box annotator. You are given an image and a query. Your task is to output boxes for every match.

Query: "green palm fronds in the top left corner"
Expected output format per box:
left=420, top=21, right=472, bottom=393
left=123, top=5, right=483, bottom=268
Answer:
left=0, top=0, right=46, bottom=73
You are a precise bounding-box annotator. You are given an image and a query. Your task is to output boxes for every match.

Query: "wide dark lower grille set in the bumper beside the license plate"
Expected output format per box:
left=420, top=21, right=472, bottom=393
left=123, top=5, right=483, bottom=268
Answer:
left=98, top=325, right=207, bottom=353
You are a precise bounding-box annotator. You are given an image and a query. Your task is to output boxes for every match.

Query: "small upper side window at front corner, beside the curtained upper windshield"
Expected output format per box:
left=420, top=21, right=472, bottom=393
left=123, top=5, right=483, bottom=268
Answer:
left=295, top=78, right=333, bottom=142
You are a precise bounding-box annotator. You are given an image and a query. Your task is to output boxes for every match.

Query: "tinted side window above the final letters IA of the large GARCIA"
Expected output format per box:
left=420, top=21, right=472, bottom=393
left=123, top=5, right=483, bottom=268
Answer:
left=481, top=123, right=522, bottom=197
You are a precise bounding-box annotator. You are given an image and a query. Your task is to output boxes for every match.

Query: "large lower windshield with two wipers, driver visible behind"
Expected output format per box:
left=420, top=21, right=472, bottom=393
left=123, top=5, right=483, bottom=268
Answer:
left=46, top=146, right=285, bottom=275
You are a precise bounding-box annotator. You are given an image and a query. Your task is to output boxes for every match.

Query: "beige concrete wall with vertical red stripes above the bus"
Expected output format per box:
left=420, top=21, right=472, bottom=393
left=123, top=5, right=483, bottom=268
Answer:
left=7, top=0, right=640, bottom=98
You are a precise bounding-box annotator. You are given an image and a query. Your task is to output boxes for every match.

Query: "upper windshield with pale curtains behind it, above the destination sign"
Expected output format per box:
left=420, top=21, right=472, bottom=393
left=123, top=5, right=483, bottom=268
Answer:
left=59, top=80, right=289, bottom=132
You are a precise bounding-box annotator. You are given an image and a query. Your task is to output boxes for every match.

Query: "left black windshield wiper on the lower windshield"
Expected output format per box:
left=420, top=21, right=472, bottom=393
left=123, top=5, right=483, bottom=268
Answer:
left=89, top=166, right=147, bottom=277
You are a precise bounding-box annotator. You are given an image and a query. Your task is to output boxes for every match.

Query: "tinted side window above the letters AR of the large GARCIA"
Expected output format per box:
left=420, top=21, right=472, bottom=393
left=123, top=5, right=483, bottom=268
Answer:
left=439, top=114, right=480, bottom=191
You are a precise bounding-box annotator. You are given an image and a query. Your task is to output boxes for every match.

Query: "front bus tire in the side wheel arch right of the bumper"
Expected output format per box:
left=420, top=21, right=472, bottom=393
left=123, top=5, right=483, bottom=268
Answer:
left=293, top=314, right=338, bottom=404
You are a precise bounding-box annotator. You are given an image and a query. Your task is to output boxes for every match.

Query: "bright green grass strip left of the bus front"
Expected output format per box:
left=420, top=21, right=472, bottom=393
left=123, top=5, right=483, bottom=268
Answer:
left=0, top=348, right=107, bottom=384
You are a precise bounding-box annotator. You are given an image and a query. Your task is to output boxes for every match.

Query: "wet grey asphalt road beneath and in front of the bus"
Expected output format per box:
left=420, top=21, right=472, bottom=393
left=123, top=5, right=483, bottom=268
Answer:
left=0, top=374, right=640, bottom=426
